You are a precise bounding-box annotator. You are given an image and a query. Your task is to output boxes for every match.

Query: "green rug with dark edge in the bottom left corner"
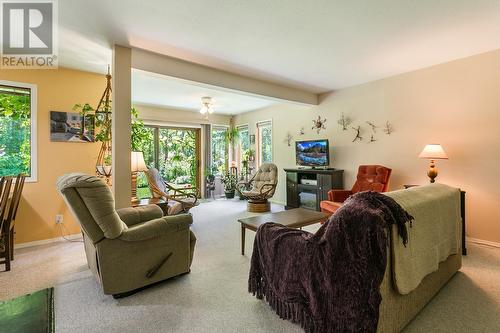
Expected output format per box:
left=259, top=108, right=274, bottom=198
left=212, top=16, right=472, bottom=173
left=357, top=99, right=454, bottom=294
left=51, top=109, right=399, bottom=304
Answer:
left=0, top=288, right=54, bottom=333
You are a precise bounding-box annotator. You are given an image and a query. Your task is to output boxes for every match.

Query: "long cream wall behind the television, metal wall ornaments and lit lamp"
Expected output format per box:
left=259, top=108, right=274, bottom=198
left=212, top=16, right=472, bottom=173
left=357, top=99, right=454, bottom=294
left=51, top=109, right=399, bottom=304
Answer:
left=234, top=50, right=500, bottom=242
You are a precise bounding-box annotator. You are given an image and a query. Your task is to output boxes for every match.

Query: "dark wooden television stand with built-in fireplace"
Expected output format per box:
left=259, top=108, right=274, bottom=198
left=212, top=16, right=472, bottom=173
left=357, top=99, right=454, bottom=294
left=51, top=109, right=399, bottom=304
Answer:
left=284, top=168, right=344, bottom=211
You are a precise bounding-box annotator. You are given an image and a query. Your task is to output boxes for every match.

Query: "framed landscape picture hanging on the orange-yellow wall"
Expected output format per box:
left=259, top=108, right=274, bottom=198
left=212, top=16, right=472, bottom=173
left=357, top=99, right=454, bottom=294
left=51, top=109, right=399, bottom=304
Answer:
left=50, top=111, right=95, bottom=142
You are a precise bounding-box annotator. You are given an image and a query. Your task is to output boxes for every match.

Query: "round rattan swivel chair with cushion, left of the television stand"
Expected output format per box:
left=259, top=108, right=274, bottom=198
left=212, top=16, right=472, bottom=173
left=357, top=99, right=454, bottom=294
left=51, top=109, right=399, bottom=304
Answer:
left=236, top=163, right=278, bottom=213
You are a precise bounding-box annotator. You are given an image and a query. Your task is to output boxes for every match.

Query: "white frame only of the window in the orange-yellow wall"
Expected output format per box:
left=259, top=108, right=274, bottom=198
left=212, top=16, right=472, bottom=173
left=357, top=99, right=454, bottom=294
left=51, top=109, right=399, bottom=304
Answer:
left=0, top=80, right=38, bottom=183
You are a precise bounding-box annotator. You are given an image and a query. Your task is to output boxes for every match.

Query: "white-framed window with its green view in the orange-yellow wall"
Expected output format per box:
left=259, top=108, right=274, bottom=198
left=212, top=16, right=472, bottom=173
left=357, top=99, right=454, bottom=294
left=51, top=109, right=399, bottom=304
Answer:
left=0, top=81, right=37, bottom=181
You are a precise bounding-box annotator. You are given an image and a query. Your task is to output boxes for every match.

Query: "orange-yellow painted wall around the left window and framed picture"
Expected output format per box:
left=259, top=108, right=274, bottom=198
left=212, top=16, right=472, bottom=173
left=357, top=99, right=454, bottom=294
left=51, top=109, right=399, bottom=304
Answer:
left=0, top=69, right=106, bottom=243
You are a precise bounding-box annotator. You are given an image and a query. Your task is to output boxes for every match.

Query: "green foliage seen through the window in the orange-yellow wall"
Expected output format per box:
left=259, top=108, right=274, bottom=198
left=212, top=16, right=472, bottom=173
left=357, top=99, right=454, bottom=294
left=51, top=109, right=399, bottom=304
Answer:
left=0, top=87, right=31, bottom=176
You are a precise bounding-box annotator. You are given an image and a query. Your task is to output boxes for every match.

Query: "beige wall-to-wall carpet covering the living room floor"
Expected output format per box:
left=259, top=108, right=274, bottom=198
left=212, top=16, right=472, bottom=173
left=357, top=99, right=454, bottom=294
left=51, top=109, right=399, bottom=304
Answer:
left=0, top=200, right=500, bottom=333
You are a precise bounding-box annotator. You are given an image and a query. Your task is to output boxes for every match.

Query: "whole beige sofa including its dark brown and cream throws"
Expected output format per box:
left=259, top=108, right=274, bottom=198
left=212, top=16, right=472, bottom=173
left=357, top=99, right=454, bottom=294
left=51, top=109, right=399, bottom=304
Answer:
left=248, top=184, right=461, bottom=333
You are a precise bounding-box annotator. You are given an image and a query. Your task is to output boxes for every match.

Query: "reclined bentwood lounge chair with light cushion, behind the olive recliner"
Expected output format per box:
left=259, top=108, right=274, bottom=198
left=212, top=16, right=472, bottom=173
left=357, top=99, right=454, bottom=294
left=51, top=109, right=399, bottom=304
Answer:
left=145, top=168, right=199, bottom=215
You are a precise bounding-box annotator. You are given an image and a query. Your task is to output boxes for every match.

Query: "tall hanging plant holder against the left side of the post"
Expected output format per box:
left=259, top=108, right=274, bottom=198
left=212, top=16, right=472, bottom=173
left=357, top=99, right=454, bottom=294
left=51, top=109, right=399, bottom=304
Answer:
left=95, top=67, right=112, bottom=185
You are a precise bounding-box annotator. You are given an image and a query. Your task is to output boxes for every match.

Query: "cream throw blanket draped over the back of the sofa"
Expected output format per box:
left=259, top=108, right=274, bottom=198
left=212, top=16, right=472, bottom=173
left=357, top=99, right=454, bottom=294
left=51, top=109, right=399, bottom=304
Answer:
left=385, top=184, right=461, bottom=295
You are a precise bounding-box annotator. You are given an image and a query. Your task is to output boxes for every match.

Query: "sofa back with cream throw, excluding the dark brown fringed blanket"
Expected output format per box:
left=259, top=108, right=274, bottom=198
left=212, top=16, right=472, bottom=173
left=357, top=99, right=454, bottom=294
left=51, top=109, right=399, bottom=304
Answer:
left=377, top=184, right=462, bottom=333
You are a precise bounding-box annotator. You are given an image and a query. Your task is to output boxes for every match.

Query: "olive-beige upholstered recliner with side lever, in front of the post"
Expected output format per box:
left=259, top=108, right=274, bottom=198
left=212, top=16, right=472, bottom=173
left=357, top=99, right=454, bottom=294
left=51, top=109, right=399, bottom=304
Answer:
left=57, top=174, right=196, bottom=298
